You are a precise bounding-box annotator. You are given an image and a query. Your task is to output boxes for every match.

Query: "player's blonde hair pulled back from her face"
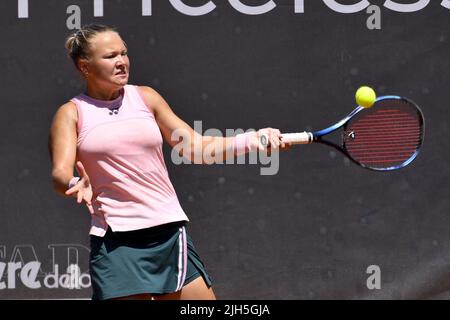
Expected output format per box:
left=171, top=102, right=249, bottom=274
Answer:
left=66, top=24, right=118, bottom=69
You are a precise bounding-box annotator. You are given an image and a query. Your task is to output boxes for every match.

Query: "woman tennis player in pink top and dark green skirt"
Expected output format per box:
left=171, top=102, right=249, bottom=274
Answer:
left=49, top=24, right=285, bottom=300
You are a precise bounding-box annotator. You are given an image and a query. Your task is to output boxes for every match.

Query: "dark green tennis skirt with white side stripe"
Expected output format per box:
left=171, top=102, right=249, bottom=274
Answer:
left=89, top=222, right=211, bottom=300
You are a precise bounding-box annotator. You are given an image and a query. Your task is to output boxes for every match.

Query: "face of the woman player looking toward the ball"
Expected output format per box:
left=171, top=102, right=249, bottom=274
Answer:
left=83, top=31, right=130, bottom=88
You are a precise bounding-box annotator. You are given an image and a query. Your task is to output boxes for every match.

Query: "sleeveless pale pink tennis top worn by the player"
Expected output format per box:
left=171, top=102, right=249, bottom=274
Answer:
left=71, top=85, right=189, bottom=237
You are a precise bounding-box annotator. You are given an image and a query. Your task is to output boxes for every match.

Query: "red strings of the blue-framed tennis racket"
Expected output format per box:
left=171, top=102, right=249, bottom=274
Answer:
left=344, top=104, right=422, bottom=168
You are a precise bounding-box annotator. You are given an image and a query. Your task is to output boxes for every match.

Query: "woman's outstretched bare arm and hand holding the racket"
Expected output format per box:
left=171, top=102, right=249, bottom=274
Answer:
left=140, top=87, right=284, bottom=163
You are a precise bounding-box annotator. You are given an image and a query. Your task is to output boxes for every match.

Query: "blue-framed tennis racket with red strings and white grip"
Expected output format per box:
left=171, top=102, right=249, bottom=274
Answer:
left=260, top=96, right=425, bottom=171
